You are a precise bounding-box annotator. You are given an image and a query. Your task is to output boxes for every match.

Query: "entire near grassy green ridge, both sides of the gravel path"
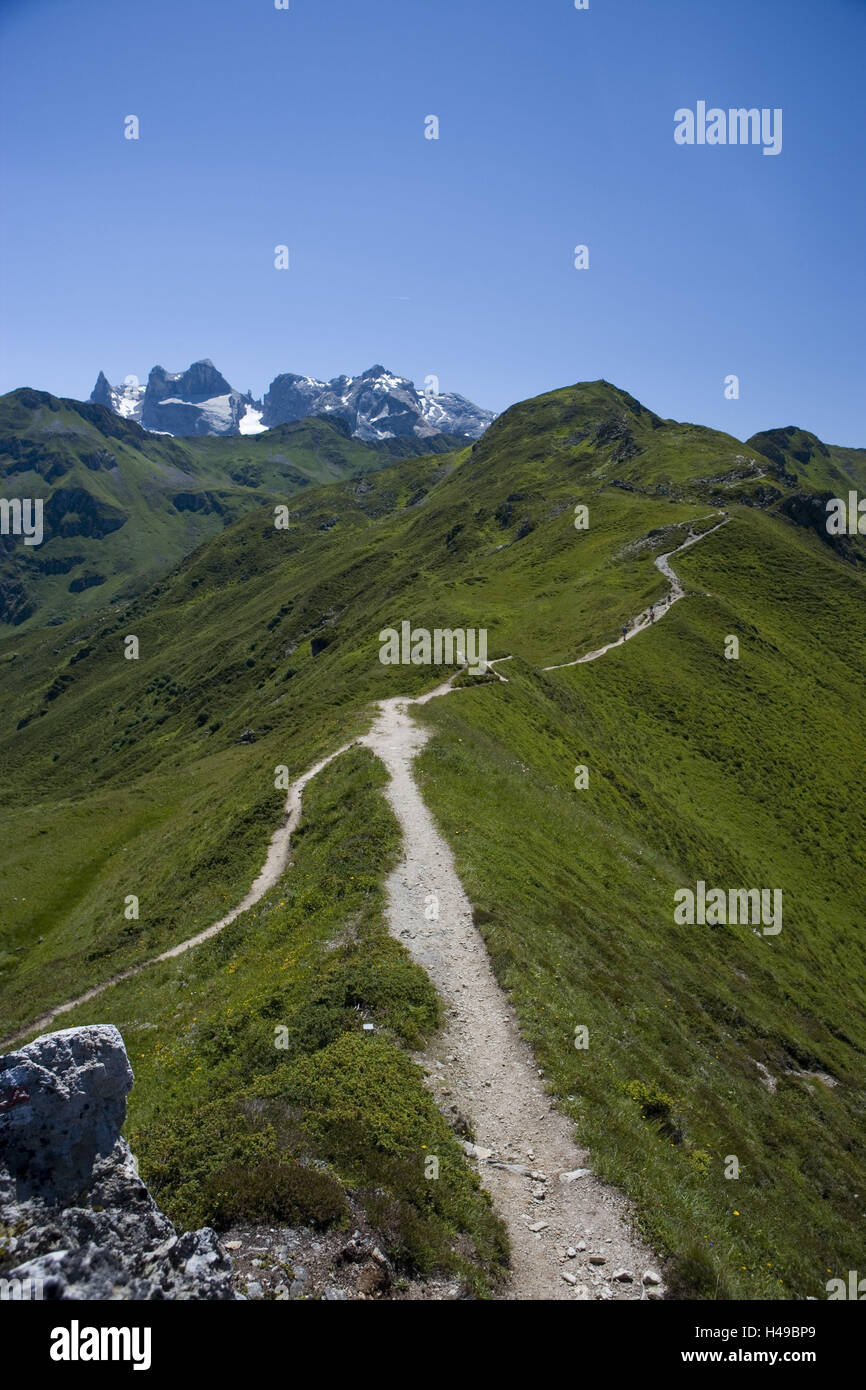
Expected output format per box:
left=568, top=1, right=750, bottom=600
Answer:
left=0, top=382, right=866, bottom=1298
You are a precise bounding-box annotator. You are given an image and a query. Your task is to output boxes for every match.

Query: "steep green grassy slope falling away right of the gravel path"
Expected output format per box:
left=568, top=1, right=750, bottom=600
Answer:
left=421, top=512, right=866, bottom=1298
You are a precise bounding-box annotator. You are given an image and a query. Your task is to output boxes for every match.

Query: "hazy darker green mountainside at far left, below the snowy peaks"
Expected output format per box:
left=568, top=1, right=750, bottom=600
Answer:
left=0, top=389, right=455, bottom=626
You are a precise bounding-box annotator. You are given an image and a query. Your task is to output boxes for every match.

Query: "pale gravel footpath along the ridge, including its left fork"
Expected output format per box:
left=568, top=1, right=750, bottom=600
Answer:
left=0, top=514, right=728, bottom=1300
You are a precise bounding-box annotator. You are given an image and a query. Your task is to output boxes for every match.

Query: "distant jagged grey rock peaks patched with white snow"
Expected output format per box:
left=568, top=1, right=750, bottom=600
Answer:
left=90, top=357, right=496, bottom=443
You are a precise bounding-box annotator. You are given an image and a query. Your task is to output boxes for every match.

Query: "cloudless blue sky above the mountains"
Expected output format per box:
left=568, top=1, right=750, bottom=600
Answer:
left=0, top=0, right=866, bottom=445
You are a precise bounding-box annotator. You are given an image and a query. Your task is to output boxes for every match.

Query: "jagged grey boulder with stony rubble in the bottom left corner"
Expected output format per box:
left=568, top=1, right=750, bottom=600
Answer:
left=0, top=1024, right=236, bottom=1300
